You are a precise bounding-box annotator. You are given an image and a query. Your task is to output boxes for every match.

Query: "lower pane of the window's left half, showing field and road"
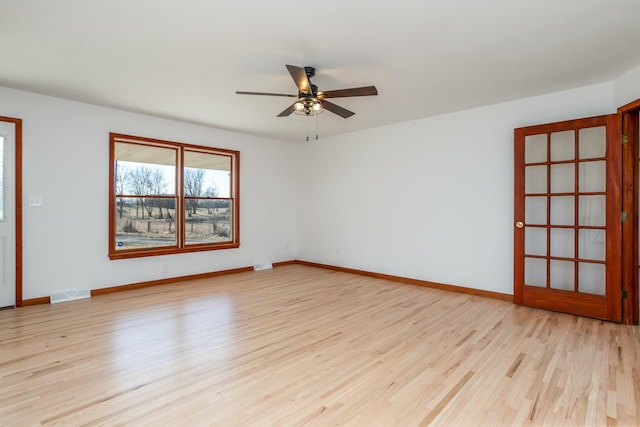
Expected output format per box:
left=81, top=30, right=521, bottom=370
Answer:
left=114, top=197, right=177, bottom=251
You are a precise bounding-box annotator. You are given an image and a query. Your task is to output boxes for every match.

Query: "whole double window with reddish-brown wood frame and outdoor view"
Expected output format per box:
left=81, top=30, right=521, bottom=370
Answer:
left=109, top=133, right=240, bottom=259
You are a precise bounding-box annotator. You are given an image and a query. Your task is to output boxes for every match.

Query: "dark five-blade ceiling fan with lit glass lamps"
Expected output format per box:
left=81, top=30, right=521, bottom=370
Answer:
left=236, top=65, right=378, bottom=119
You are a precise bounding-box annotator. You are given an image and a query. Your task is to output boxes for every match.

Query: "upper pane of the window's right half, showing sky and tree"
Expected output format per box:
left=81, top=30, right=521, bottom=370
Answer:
left=184, top=151, right=231, bottom=198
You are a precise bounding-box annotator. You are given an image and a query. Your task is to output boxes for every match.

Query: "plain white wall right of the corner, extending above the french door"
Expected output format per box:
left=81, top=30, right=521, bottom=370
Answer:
left=298, top=83, right=615, bottom=294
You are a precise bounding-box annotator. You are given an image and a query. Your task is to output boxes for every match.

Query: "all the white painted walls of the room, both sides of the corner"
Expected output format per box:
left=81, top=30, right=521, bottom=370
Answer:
left=0, top=75, right=640, bottom=299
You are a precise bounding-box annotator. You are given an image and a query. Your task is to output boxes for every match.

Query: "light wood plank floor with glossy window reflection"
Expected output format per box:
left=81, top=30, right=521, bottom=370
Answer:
left=0, top=265, right=640, bottom=426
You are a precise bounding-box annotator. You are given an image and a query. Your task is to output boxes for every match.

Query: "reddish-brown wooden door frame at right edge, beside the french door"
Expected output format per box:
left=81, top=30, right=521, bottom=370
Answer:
left=618, top=99, right=640, bottom=325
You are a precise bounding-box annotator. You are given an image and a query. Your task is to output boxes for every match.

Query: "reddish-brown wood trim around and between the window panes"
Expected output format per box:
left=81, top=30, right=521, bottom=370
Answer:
left=108, top=132, right=240, bottom=260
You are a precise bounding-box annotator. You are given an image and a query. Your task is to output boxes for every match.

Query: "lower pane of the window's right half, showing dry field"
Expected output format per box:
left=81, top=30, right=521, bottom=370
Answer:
left=185, top=199, right=233, bottom=245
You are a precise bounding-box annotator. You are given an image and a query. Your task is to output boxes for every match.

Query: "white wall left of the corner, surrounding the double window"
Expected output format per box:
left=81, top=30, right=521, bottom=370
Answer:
left=0, top=88, right=296, bottom=299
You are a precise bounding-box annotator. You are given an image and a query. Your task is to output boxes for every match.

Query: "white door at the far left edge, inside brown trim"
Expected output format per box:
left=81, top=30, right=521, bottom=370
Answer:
left=0, top=122, right=16, bottom=308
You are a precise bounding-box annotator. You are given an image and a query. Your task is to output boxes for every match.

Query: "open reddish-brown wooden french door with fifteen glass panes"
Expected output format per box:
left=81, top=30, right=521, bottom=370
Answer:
left=514, top=114, right=624, bottom=322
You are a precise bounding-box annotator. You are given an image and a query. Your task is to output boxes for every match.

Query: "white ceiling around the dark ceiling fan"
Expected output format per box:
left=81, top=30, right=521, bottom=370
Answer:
left=0, top=0, right=640, bottom=142
